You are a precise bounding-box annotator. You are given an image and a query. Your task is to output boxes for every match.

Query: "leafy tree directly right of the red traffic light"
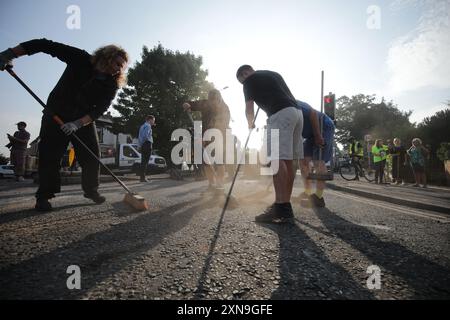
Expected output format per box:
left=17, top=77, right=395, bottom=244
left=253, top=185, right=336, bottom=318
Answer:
left=336, top=94, right=415, bottom=143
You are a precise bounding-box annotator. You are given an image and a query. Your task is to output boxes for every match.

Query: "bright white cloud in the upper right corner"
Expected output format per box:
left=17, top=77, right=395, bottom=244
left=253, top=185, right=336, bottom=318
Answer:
left=386, top=0, right=450, bottom=92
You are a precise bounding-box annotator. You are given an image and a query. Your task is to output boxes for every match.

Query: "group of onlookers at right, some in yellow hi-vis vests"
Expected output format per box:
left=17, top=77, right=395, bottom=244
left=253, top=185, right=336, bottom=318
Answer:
left=349, top=138, right=430, bottom=188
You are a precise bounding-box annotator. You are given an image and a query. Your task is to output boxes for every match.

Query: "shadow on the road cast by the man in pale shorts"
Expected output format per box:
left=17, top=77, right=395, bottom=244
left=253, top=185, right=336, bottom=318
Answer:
left=261, top=224, right=374, bottom=300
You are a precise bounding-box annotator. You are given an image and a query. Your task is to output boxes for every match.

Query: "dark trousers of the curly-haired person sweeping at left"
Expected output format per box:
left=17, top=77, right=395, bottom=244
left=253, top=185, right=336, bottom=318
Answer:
left=36, top=116, right=100, bottom=199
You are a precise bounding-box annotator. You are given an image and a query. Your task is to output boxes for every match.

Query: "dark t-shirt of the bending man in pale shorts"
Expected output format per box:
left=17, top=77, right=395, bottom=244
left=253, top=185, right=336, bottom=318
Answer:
left=244, top=70, right=296, bottom=117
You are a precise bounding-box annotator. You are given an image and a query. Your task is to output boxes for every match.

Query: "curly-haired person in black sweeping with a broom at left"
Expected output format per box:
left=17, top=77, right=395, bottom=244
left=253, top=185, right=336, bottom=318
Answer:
left=0, top=39, right=128, bottom=211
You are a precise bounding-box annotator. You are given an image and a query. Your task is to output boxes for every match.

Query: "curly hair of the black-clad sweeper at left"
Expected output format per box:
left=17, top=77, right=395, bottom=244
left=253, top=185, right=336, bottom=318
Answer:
left=92, top=44, right=129, bottom=87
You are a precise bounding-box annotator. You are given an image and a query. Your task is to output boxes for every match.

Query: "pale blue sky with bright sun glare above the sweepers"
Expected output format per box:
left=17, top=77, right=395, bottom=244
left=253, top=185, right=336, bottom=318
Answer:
left=0, top=0, right=450, bottom=155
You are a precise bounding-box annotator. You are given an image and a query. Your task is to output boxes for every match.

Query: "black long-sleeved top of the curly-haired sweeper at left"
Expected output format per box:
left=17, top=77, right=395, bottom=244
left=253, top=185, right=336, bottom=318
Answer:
left=21, top=39, right=118, bottom=122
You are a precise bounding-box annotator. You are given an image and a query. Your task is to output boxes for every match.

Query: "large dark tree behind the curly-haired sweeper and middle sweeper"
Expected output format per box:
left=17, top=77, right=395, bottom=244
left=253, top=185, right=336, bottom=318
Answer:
left=113, top=44, right=214, bottom=159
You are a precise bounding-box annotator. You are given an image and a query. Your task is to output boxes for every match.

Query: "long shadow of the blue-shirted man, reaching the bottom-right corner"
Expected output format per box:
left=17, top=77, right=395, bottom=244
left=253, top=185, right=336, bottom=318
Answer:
left=314, top=208, right=450, bottom=299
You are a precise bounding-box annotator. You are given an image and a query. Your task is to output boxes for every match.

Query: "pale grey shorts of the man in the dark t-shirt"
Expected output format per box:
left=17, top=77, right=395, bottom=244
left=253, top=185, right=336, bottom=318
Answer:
left=267, top=107, right=303, bottom=160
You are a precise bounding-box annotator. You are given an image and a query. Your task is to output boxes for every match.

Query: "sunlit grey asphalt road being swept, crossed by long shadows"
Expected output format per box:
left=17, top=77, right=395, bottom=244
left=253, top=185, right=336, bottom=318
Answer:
left=0, top=179, right=450, bottom=300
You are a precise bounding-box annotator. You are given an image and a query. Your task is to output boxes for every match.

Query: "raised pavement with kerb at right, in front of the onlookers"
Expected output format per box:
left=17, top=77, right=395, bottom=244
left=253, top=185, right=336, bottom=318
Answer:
left=327, top=174, right=450, bottom=214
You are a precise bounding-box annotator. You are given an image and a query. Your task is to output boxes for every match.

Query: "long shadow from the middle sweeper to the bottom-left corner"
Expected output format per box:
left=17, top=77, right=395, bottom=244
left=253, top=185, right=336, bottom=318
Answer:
left=0, top=201, right=217, bottom=299
